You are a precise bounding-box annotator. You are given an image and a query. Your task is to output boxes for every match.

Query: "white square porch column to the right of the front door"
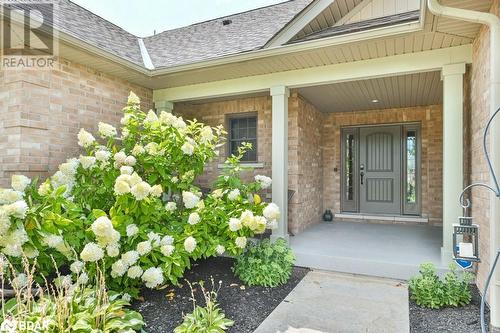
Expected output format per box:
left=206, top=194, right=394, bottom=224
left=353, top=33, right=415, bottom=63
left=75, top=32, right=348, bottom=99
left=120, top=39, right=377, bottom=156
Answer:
left=441, top=63, right=465, bottom=263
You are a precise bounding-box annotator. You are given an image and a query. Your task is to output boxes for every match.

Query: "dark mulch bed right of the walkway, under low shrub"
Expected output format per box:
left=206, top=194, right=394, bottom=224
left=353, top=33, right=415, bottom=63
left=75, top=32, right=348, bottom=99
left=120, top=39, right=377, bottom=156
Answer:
left=410, top=286, right=489, bottom=333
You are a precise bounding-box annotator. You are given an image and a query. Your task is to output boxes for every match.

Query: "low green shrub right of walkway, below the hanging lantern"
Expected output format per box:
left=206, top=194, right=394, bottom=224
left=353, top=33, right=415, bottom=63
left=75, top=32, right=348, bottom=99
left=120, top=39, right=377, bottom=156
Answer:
left=410, top=263, right=473, bottom=309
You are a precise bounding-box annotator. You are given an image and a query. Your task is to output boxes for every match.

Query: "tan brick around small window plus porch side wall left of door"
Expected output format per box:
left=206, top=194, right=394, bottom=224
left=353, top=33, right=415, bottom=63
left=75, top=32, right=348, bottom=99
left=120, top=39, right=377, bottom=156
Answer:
left=174, top=93, right=322, bottom=233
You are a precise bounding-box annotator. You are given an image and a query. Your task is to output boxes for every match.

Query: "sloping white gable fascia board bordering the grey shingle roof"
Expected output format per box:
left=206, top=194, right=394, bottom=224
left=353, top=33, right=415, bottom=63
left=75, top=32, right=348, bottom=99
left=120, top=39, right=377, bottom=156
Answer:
left=264, top=0, right=335, bottom=48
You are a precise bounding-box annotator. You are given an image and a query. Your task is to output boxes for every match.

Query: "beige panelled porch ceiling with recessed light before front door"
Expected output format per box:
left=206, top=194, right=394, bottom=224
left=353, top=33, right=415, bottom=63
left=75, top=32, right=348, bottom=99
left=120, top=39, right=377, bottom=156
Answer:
left=298, top=72, right=443, bottom=112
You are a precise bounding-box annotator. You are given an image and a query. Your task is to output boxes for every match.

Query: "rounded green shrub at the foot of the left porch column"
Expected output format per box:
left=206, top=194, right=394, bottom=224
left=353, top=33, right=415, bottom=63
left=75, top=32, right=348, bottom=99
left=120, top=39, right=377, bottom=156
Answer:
left=233, top=239, right=295, bottom=287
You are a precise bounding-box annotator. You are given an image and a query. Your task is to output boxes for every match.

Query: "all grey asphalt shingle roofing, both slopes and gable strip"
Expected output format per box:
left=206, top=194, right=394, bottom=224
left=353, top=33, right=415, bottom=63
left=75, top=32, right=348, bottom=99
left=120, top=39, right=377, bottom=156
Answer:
left=4, top=0, right=419, bottom=68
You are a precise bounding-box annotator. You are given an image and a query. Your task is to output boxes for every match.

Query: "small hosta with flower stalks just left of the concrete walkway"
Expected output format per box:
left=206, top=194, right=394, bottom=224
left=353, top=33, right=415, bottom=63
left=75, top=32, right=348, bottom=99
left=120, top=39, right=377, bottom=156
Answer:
left=174, top=279, right=234, bottom=333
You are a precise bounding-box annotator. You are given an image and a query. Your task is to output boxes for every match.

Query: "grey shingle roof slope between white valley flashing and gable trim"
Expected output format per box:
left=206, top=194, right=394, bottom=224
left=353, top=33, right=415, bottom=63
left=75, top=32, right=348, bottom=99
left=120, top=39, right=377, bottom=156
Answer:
left=144, top=0, right=313, bottom=68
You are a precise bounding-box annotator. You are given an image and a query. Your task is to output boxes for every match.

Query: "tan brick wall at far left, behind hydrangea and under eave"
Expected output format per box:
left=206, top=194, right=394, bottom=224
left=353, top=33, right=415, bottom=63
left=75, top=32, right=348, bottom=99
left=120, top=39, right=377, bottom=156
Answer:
left=0, top=59, right=152, bottom=186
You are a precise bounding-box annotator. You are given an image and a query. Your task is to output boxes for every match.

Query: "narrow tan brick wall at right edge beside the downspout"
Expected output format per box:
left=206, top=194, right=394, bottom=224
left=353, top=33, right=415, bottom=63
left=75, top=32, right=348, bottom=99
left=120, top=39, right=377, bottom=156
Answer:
left=469, top=0, right=500, bottom=296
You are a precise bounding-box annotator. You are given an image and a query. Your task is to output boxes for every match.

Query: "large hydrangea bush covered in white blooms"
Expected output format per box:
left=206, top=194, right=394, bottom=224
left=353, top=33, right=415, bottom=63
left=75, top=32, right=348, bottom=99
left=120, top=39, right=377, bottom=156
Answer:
left=0, top=93, right=280, bottom=296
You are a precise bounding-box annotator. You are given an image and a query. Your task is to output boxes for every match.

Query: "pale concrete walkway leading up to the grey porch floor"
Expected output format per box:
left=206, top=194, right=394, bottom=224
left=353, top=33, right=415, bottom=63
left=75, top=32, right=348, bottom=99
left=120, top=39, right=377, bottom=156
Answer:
left=255, top=271, right=409, bottom=333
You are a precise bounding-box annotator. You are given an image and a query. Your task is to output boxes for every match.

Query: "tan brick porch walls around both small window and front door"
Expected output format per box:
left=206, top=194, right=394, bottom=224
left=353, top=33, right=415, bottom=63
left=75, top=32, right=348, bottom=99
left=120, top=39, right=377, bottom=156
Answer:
left=174, top=93, right=442, bottom=234
